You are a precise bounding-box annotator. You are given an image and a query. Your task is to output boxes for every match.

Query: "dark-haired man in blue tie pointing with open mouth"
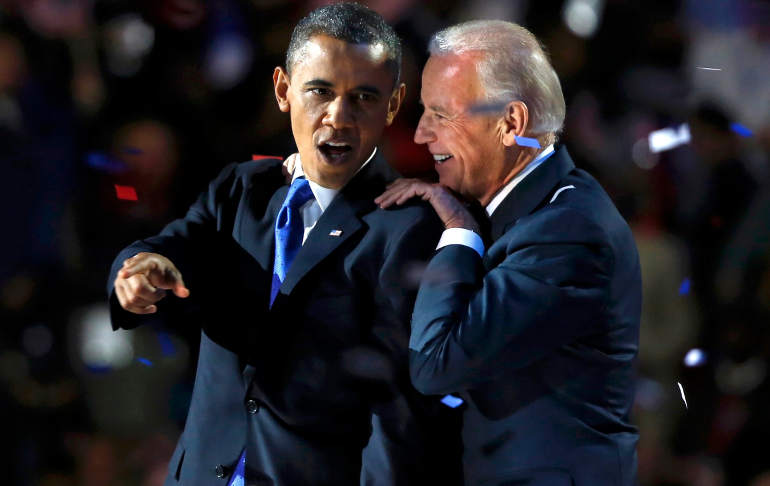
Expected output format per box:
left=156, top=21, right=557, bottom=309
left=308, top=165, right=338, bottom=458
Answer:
left=109, top=4, right=462, bottom=486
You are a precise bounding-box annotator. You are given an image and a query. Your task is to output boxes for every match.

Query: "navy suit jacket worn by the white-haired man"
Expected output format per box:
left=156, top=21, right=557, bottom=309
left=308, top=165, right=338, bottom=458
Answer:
left=410, top=148, right=641, bottom=486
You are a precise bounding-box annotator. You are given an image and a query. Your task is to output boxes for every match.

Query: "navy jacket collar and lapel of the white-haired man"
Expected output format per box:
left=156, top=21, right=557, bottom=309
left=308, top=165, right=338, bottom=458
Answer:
left=490, top=147, right=575, bottom=242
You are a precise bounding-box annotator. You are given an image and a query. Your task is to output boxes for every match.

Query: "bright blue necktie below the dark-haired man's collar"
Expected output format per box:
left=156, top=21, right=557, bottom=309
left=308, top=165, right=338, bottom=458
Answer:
left=270, top=177, right=313, bottom=307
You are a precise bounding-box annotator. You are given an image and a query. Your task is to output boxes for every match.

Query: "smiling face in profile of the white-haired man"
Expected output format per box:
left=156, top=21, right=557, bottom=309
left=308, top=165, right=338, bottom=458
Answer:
left=414, top=53, right=511, bottom=205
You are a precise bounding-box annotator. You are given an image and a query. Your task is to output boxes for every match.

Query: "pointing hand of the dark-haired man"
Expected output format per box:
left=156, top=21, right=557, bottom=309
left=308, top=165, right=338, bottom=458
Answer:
left=115, top=252, right=190, bottom=314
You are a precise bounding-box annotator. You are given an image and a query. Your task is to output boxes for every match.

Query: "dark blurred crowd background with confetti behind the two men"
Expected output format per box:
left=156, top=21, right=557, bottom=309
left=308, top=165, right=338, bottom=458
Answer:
left=0, top=0, right=770, bottom=486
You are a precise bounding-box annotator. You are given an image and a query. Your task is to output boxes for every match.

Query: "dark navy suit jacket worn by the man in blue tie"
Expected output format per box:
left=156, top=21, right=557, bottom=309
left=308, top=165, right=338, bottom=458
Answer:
left=109, top=157, right=462, bottom=486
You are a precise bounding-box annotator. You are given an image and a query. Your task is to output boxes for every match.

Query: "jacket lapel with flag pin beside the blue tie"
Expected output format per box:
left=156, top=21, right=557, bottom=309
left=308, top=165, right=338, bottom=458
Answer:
left=274, top=150, right=391, bottom=294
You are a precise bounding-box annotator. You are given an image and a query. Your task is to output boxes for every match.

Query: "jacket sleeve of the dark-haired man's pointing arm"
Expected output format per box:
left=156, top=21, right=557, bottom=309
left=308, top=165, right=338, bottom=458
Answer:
left=107, top=164, right=243, bottom=329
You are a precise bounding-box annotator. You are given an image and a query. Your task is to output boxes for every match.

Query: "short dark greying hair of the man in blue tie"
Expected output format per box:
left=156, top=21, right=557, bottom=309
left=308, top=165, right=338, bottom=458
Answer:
left=286, top=2, right=401, bottom=86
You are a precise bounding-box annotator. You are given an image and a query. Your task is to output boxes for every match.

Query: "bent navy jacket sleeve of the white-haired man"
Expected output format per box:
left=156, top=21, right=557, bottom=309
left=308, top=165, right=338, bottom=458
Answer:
left=409, top=207, right=614, bottom=393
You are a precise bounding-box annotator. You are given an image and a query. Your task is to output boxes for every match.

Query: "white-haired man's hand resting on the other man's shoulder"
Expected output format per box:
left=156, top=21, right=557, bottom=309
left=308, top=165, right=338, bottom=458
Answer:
left=374, top=179, right=480, bottom=233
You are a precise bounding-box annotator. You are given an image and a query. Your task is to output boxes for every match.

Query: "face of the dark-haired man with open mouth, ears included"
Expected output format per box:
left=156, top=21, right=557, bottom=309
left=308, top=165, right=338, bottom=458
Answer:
left=273, top=35, right=405, bottom=189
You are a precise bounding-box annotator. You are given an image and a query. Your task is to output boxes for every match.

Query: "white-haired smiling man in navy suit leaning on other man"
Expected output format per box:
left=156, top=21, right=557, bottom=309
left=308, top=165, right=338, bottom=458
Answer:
left=376, top=21, right=641, bottom=486
